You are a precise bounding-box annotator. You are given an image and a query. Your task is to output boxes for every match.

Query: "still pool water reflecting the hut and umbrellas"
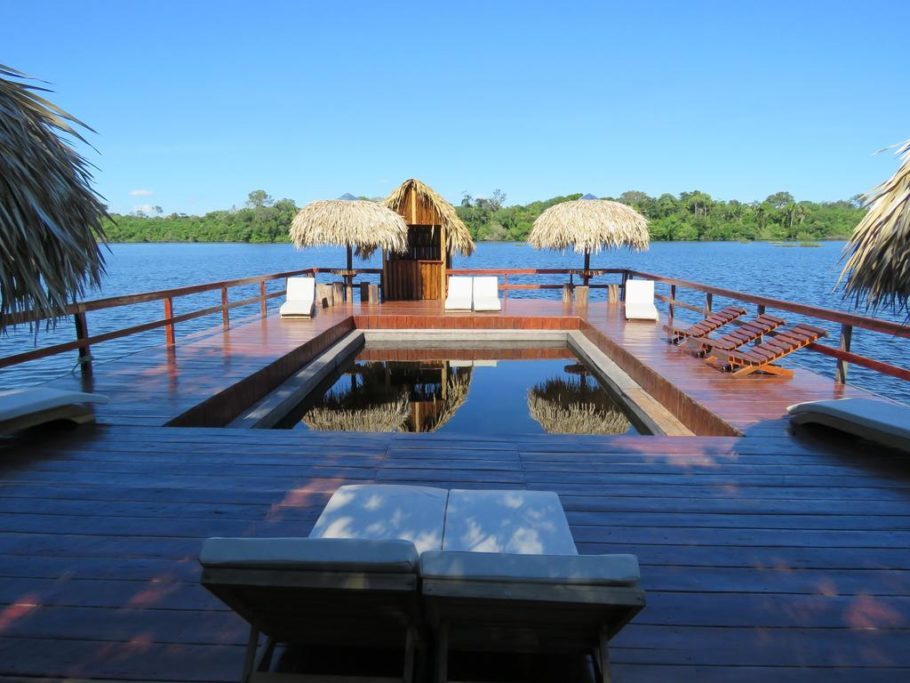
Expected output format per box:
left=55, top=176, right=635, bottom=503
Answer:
left=276, top=347, right=638, bottom=435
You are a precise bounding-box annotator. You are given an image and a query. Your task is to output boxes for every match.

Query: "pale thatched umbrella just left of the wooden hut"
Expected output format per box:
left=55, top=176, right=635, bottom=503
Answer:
left=290, top=199, right=408, bottom=269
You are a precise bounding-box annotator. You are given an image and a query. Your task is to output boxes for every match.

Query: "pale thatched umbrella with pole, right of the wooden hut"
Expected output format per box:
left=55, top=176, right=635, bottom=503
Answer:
left=528, top=199, right=650, bottom=285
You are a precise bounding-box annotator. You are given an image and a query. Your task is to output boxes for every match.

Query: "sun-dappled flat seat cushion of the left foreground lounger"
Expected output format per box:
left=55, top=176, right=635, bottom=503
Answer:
left=310, top=484, right=449, bottom=552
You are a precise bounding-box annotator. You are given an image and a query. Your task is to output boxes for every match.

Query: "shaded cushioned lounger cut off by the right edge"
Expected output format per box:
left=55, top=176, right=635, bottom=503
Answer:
left=787, top=398, right=910, bottom=452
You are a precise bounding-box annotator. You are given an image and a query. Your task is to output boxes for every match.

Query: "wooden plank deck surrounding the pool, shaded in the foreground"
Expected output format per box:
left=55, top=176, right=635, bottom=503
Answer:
left=0, top=300, right=910, bottom=683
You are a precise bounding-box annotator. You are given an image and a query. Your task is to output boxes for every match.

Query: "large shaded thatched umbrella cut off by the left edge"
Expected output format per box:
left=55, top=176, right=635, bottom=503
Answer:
left=0, top=65, right=107, bottom=327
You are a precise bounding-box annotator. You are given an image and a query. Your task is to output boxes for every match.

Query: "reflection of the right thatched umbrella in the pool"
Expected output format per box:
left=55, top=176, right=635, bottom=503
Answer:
left=528, top=377, right=631, bottom=434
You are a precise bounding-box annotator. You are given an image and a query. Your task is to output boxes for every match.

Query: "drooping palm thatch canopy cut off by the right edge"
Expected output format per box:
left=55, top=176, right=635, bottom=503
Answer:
left=840, top=140, right=910, bottom=310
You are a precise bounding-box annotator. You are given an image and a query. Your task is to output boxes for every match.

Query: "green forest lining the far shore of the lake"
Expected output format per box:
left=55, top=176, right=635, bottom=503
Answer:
left=105, top=190, right=864, bottom=243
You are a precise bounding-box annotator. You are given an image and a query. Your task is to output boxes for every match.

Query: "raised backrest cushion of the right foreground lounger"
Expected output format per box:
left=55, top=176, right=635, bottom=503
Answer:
left=420, top=550, right=641, bottom=586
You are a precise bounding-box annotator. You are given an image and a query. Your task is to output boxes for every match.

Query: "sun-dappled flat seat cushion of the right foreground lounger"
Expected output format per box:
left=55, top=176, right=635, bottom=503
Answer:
left=442, top=489, right=578, bottom=555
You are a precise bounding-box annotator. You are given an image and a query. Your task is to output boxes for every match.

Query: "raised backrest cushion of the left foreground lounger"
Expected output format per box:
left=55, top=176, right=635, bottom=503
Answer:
left=199, top=538, right=418, bottom=573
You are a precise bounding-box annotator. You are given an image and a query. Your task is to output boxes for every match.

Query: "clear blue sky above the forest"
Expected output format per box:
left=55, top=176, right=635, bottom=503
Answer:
left=7, top=0, right=910, bottom=213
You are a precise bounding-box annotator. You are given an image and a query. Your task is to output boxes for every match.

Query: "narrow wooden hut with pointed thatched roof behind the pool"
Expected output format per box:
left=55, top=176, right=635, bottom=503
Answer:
left=382, top=178, right=474, bottom=301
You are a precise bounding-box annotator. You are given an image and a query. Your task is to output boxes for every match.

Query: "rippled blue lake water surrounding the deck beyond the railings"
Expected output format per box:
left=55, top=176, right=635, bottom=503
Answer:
left=0, top=242, right=910, bottom=402
